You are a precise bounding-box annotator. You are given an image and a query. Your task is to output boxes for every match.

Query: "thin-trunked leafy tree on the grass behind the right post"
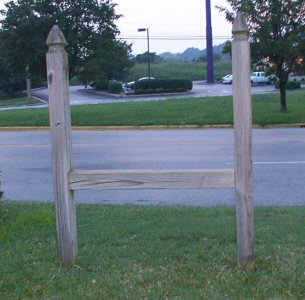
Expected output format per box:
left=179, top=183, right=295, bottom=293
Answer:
left=219, top=0, right=305, bottom=112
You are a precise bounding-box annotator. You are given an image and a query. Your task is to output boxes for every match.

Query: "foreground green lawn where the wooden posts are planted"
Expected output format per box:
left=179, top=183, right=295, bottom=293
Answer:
left=0, top=202, right=305, bottom=299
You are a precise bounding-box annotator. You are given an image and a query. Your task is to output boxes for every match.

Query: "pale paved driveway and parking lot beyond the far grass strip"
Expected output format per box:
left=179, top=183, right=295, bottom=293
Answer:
left=32, top=81, right=275, bottom=105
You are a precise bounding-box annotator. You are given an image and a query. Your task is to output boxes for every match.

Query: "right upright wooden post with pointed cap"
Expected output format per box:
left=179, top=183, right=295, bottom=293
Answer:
left=232, top=13, right=255, bottom=270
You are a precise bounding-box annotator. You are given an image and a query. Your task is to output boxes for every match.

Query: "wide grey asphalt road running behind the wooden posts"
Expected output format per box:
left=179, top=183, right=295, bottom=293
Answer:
left=0, top=128, right=305, bottom=206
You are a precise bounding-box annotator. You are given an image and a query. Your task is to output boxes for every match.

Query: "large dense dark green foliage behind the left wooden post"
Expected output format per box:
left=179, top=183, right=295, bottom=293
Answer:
left=0, top=0, right=133, bottom=93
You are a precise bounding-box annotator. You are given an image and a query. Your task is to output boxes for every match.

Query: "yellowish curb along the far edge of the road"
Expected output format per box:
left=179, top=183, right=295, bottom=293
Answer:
left=0, top=123, right=305, bottom=131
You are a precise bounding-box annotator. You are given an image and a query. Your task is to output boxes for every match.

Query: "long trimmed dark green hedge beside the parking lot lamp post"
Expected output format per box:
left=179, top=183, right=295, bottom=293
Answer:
left=134, top=79, right=193, bottom=94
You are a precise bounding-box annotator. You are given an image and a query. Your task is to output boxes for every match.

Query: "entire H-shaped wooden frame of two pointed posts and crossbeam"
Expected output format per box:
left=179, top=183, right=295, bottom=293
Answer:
left=47, top=12, right=255, bottom=270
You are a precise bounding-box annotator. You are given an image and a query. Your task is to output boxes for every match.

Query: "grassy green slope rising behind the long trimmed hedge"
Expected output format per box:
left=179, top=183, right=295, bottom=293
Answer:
left=126, top=61, right=232, bottom=81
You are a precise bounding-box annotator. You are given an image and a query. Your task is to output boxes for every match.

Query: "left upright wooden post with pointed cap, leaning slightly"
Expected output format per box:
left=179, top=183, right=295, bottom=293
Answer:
left=47, top=25, right=77, bottom=266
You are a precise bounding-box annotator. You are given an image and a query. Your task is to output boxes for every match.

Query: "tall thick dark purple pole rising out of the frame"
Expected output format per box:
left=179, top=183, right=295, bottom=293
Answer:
left=205, top=0, right=214, bottom=83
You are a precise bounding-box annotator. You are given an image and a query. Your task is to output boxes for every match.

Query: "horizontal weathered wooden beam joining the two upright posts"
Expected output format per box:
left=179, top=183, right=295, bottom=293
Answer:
left=69, top=169, right=235, bottom=190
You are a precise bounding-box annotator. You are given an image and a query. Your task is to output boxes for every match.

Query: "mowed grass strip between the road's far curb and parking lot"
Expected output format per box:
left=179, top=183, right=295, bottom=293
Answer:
left=0, top=91, right=305, bottom=127
